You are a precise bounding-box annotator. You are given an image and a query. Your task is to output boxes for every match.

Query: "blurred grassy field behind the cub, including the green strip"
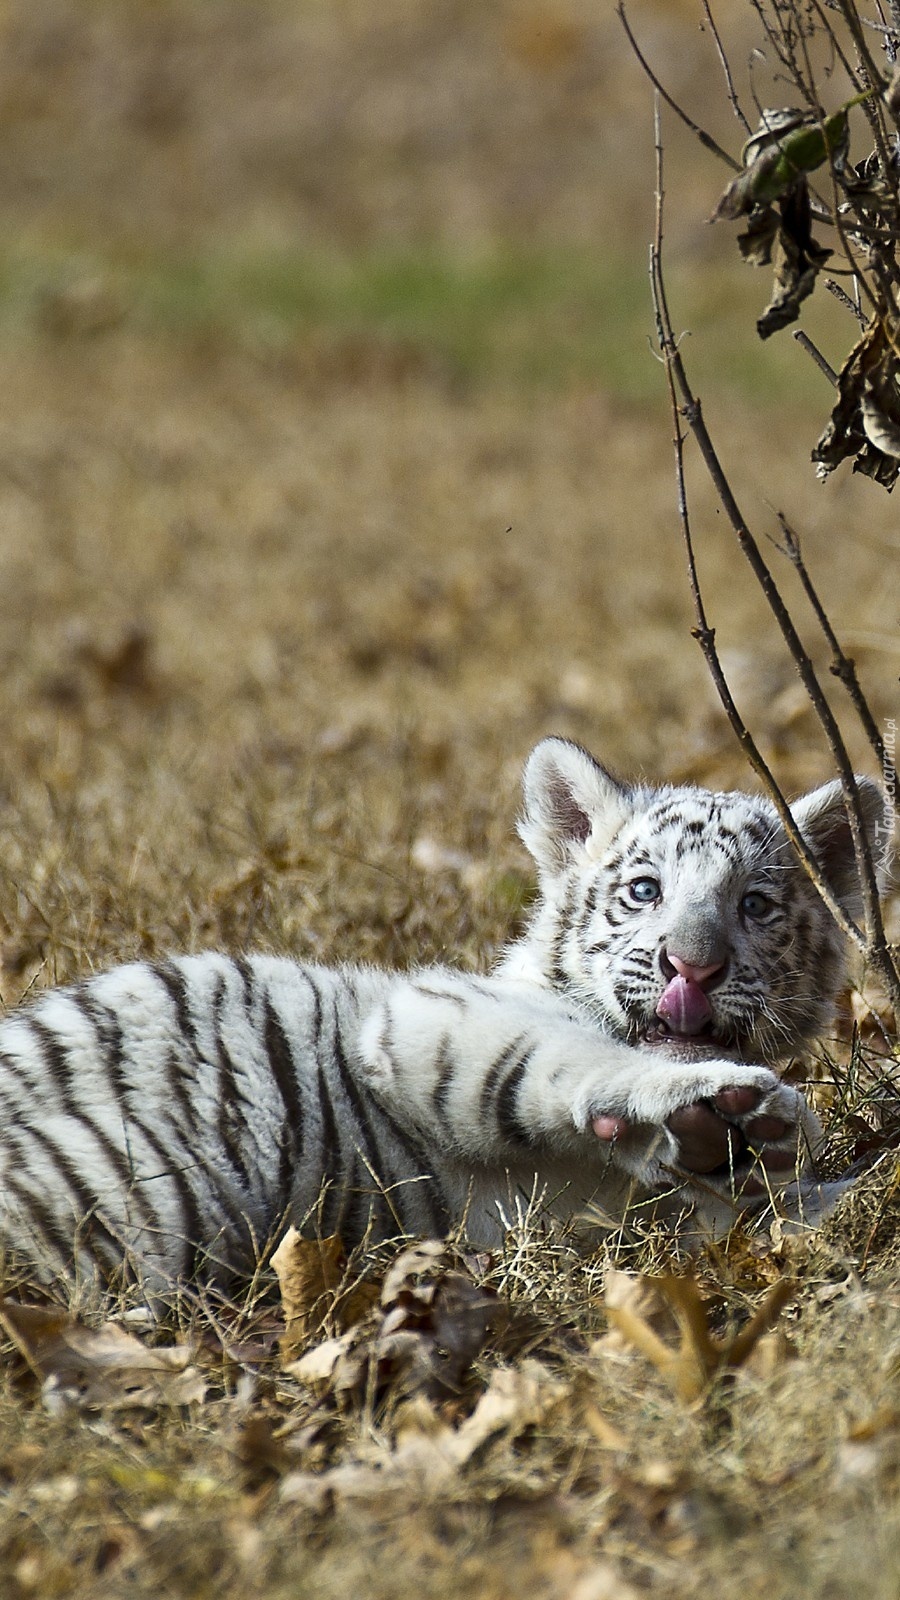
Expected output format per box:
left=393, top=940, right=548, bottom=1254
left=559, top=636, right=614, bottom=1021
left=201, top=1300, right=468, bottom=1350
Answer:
left=0, top=0, right=898, bottom=998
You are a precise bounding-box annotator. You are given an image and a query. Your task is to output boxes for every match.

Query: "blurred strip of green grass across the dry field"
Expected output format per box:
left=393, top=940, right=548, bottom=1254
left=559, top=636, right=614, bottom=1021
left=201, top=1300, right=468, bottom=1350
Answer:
left=0, top=248, right=839, bottom=408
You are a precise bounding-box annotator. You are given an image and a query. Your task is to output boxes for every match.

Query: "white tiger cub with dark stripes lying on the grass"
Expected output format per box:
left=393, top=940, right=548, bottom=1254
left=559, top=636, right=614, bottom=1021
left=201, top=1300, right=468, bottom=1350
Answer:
left=0, top=739, right=881, bottom=1291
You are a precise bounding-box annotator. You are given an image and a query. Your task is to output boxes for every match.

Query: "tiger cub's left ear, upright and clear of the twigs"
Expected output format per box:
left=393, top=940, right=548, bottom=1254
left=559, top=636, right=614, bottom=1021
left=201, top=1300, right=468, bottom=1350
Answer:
left=519, top=739, right=631, bottom=874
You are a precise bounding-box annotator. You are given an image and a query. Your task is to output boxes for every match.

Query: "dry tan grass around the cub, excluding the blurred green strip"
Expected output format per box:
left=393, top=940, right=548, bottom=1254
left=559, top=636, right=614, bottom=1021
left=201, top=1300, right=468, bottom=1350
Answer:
left=0, top=0, right=900, bottom=1600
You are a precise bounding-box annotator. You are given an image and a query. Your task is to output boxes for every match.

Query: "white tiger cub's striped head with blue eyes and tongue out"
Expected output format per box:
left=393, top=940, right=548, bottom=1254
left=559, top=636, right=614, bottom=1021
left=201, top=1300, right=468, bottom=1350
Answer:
left=506, top=739, right=887, bottom=1062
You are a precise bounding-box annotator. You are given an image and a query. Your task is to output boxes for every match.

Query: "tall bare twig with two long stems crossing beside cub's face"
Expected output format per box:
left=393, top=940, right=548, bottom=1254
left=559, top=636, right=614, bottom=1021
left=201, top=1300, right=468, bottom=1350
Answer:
left=652, top=98, right=900, bottom=1013
